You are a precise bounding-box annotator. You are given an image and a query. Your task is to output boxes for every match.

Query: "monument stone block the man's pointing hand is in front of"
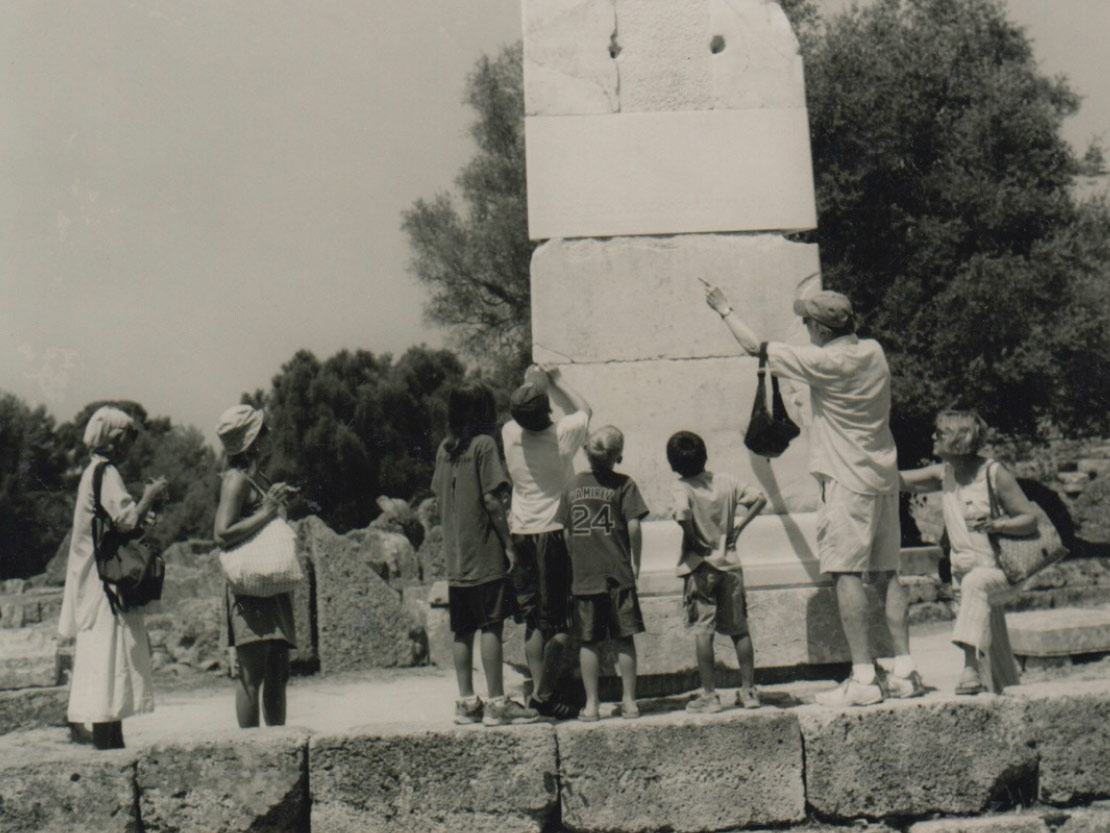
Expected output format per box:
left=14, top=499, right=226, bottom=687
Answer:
left=531, top=234, right=820, bottom=364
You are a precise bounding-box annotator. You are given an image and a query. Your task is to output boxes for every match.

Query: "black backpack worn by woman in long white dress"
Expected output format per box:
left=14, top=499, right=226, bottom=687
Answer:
left=92, top=461, right=165, bottom=613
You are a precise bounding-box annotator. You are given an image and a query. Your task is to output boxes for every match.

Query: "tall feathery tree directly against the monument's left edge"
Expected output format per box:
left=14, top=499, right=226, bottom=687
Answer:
left=401, top=43, right=534, bottom=386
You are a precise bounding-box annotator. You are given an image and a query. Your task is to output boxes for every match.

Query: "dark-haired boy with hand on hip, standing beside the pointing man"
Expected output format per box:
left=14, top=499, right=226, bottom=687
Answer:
left=667, top=431, right=767, bottom=714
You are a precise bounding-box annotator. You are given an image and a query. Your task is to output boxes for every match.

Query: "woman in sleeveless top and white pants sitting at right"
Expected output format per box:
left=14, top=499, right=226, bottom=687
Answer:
left=901, top=411, right=1037, bottom=694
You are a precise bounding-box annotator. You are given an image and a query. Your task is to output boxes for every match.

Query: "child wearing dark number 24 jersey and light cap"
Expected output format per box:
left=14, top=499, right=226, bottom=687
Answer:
left=559, top=425, right=647, bottom=722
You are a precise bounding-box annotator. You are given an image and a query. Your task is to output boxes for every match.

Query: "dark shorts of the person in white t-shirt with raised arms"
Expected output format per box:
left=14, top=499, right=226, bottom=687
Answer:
left=513, top=530, right=571, bottom=639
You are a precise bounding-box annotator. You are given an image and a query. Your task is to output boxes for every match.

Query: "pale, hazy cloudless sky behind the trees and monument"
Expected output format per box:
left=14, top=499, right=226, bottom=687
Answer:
left=0, top=0, right=1110, bottom=441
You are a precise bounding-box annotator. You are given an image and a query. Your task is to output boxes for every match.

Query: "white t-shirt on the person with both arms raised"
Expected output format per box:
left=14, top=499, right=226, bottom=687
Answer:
left=501, top=411, right=589, bottom=534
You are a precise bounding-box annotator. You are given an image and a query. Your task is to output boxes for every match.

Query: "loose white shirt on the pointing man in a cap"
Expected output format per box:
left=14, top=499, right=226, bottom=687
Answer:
left=767, top=334, right=898, bottom=494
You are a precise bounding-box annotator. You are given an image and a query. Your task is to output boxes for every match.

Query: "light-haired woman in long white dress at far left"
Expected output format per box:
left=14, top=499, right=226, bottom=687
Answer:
left=58, top=407, right=165, bottom=749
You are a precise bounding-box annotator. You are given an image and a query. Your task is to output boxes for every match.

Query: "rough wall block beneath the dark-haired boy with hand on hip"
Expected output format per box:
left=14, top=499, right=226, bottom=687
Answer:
left=556, top=710, right=806, bottom=833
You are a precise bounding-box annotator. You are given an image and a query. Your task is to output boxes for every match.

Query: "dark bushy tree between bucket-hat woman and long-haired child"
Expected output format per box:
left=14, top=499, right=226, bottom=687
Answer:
left=257, top=347, right=465, bottom=532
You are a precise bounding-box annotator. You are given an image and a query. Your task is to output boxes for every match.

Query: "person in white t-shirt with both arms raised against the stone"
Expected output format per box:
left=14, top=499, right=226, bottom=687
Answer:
left=501, top=365, right=591, bottom=719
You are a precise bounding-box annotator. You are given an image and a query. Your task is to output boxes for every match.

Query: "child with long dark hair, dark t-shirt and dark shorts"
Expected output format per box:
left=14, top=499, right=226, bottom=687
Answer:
left=432, top=382, right=539, bottom=726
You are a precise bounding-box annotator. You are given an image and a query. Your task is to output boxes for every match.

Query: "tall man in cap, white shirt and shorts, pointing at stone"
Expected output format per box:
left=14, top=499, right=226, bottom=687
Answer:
left=706, top=287, right=925, bottom=705
